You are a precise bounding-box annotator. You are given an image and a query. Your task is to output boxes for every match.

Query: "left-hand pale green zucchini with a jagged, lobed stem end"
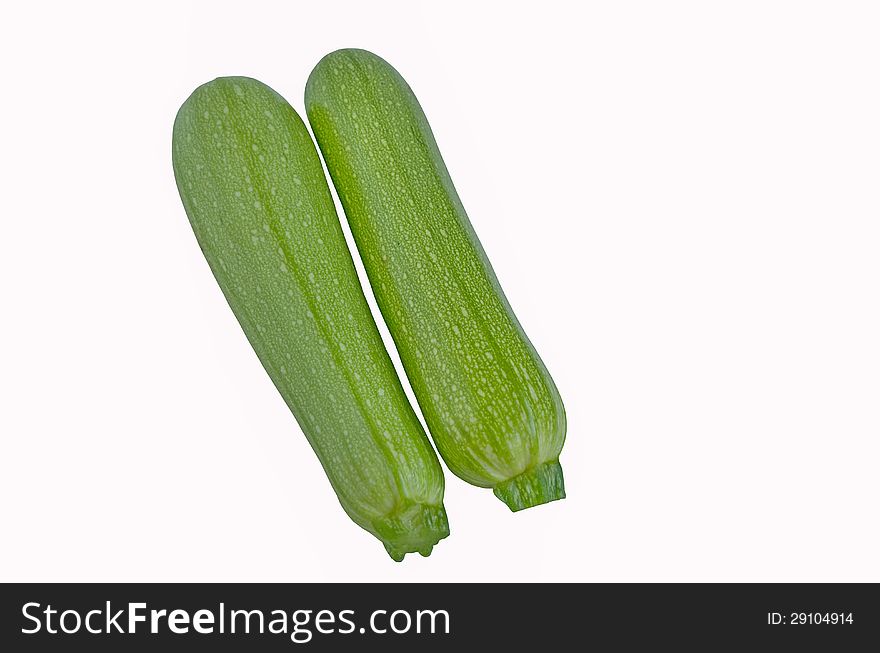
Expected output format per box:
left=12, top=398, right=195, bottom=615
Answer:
left=172, top=77, right=449, bottom=561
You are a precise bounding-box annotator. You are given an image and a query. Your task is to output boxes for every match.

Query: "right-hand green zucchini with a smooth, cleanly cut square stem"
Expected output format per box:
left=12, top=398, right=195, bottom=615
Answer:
left=305, top=49, right=566, bottom=511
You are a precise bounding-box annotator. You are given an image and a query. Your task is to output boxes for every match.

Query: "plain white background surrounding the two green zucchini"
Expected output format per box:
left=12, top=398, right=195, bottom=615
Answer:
left=0, top=0, right=880, bottom=581
